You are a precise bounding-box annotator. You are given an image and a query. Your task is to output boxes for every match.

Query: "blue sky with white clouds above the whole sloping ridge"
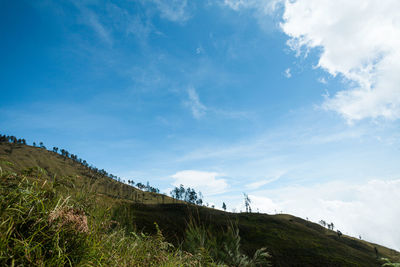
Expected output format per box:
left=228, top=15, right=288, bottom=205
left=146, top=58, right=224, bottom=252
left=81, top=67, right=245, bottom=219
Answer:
left=0, top=0, right=400, bottom=249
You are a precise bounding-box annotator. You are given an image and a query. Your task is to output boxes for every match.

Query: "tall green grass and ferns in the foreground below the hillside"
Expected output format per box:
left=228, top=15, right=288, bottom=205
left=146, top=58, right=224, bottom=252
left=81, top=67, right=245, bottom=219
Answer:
left=0, top=173, right=270, bottom=266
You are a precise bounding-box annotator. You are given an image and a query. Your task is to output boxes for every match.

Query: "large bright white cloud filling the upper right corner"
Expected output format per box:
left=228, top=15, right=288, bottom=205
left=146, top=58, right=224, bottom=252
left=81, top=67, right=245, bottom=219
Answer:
left=281, top=0, right=400, bottom=121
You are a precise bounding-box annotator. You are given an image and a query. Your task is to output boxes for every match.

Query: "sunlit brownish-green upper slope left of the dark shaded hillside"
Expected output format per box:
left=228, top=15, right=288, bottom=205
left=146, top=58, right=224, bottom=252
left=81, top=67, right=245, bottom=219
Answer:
left=0, top=143, right=180, bottom=204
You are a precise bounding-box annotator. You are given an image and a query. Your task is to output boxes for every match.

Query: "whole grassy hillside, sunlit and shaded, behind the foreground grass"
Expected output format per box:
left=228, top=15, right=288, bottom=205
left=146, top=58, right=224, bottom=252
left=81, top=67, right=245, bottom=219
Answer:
left=0, top=143, right=400, bottom=266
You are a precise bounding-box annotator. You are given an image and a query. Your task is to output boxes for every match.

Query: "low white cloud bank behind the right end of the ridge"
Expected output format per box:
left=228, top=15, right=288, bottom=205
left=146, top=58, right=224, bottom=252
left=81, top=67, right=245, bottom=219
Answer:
left=250, top=179, right=400, bottom=249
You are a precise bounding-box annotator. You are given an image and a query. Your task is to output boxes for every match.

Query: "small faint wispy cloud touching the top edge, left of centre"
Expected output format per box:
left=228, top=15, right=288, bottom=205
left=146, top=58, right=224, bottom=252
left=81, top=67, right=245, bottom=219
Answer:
left=153, top=0, right=190, bottom=23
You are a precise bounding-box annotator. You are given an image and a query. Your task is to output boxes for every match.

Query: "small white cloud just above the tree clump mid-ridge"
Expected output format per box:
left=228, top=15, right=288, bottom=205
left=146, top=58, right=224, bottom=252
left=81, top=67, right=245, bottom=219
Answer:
left=171, top=170, right=228, bottom=196
